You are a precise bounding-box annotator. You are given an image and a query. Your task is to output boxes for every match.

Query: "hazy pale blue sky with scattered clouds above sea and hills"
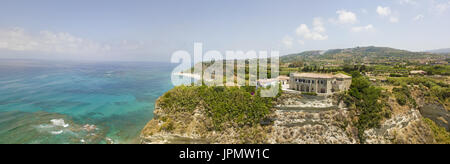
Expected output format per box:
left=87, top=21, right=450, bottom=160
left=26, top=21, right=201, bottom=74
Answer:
left=0, top=0, right=450, bottom=62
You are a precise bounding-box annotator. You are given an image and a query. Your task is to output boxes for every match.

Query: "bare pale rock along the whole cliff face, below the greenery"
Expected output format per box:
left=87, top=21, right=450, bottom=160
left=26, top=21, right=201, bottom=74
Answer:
left=141, top=93, right=435, bottom=144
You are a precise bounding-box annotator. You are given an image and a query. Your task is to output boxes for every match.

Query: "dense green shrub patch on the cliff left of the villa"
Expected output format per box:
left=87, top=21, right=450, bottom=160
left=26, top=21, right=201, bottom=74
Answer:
left=159, top=86, right=273, bottom=131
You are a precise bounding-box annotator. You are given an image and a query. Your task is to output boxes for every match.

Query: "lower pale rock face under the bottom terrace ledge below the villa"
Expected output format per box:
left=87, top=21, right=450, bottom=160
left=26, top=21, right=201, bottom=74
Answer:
left=268, top=109, right=358, bottom=144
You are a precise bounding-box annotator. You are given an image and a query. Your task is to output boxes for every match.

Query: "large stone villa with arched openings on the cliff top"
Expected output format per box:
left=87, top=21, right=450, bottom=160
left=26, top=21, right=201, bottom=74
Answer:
left=289, top=73, right=352, bottom=95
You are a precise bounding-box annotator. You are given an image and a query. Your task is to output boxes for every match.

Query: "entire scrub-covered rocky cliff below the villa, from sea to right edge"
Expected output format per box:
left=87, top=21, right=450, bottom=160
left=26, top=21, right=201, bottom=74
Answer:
left=140, top=76, right=450, bottom=144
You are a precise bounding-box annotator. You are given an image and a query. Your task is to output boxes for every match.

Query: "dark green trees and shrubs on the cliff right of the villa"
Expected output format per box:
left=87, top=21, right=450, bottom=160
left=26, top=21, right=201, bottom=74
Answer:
left=341, top=72, right=450, bottom=143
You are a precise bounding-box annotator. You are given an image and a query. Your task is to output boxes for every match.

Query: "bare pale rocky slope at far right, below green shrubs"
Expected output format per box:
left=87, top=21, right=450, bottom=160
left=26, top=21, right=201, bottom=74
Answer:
left=364, top=86, right=444, bottom=144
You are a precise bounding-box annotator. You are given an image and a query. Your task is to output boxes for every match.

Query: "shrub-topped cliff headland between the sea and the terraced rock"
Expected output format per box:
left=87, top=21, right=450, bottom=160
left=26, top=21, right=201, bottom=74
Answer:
left=141, top=87, right=272, bottom=143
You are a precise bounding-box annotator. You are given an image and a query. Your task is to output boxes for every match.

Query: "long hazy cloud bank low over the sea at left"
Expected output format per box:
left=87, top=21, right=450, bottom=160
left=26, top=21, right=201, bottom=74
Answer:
left=0, top=28, right=148, bottom=58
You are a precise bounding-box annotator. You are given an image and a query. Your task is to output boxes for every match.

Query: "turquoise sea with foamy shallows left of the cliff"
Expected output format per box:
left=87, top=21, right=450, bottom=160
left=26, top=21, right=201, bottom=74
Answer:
left=0, top=60, right=179, bottom=143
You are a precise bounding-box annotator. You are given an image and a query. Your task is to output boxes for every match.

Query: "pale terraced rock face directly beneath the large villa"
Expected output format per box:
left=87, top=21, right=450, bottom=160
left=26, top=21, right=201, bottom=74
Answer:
left=268, top=92, right=358, bottom=144
